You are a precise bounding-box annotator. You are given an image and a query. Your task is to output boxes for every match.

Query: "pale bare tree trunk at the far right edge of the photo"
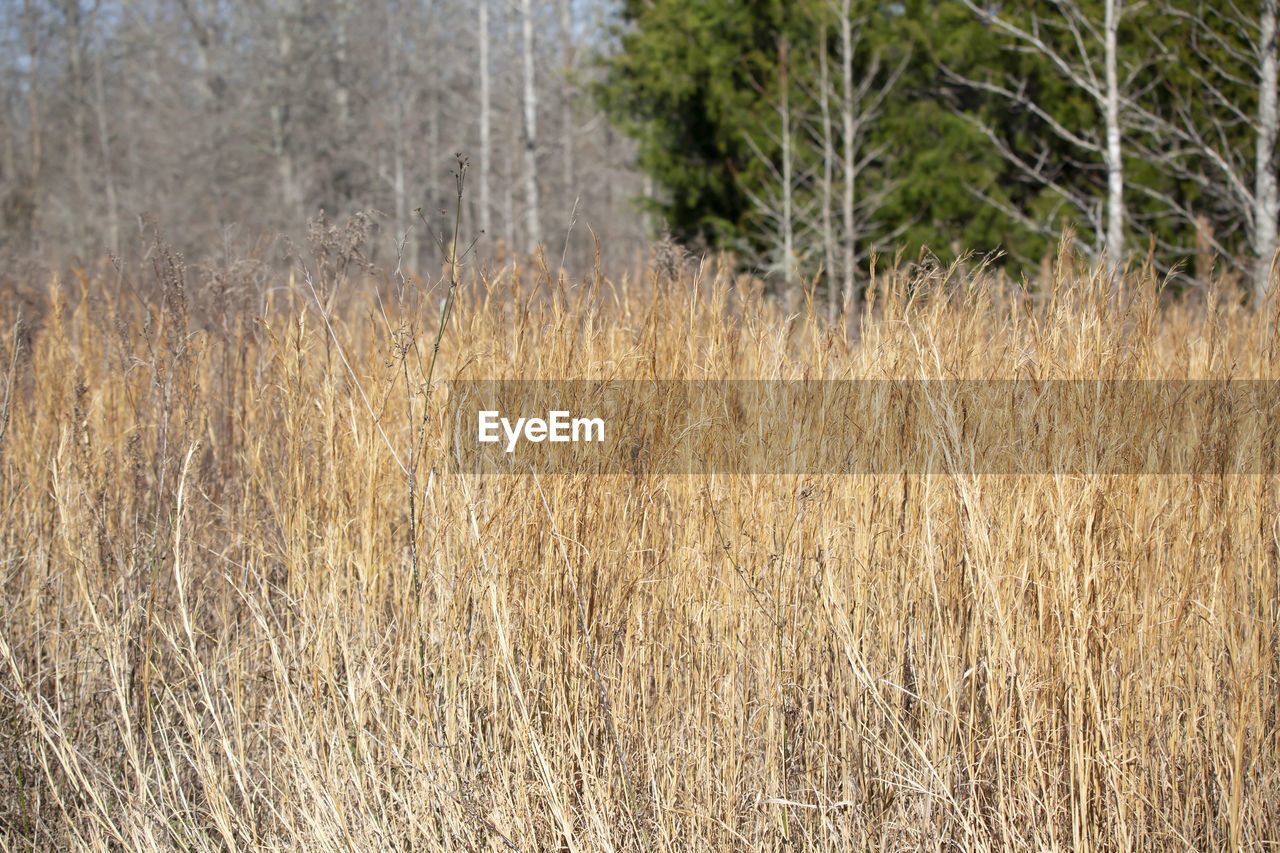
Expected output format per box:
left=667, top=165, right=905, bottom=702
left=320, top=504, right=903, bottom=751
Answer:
left=1253, top=0, right=1280, bottom=301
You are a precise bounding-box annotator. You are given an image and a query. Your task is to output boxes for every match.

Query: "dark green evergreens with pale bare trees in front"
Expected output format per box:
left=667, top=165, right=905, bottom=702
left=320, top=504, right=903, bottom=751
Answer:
left=595, top=0, right=1280, bottom=303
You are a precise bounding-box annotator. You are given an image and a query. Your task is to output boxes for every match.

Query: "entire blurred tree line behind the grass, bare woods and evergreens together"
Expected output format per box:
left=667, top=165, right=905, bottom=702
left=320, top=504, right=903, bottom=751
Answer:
left=0, top=0, right=1280, bottom=300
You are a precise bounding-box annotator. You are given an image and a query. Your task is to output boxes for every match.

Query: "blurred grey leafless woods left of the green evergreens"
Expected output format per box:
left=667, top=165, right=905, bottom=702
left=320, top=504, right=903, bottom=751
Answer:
left=0, top=0, right=645, bottom=266
